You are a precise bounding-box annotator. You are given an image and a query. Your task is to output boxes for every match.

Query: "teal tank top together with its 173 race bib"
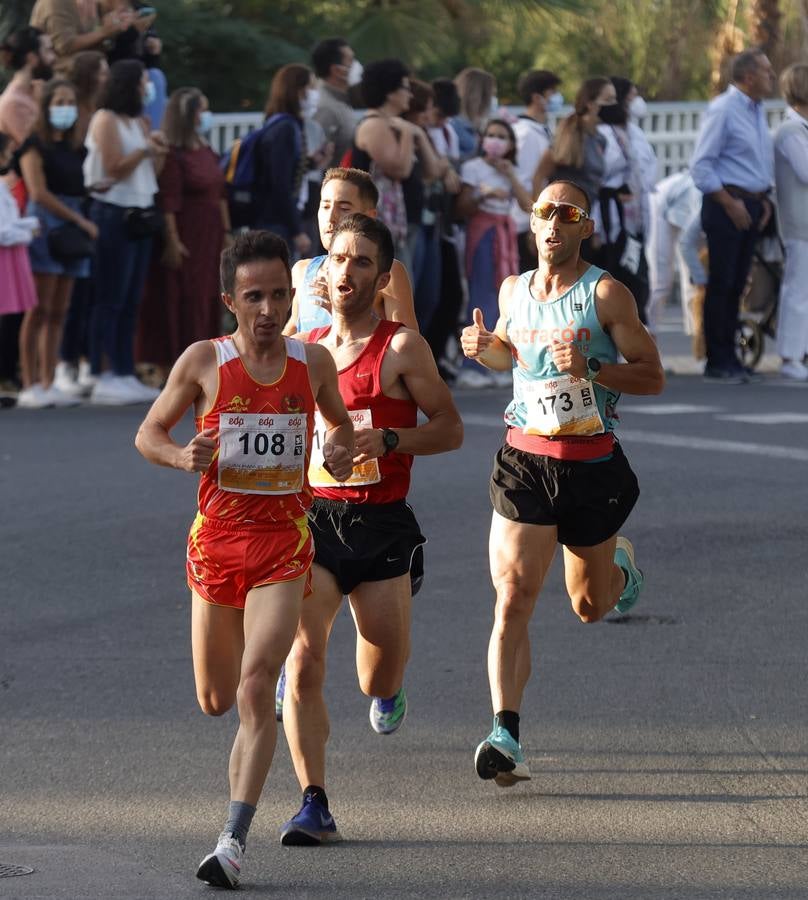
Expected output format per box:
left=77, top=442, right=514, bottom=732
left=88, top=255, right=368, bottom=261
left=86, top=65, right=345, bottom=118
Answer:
left=505, top=266, right=620, bottom=450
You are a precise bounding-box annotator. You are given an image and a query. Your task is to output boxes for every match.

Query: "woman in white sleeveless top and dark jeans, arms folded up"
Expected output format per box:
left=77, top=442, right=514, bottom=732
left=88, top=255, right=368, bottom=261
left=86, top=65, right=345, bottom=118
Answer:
left=84, top=59, right=167, bottom=406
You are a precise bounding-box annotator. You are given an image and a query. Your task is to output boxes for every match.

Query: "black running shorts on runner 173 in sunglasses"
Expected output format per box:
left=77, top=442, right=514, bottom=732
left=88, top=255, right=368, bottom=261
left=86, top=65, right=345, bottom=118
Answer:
left=490, top=442, right=640, bottom=544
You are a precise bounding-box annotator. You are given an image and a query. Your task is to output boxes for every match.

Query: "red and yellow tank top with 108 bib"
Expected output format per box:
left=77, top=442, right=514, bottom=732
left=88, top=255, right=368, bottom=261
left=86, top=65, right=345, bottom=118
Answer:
left=196, top=337, right=314, bottom=527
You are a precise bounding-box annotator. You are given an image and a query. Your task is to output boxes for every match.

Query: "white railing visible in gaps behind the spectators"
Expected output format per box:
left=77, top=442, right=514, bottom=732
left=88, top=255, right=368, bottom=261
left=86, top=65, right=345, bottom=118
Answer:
left=211, top=100, right=786, bottom=178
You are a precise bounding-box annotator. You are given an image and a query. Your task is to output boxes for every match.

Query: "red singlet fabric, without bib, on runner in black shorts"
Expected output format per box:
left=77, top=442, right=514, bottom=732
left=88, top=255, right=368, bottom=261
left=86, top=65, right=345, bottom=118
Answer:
left=307, top=319, right=418, bottom=503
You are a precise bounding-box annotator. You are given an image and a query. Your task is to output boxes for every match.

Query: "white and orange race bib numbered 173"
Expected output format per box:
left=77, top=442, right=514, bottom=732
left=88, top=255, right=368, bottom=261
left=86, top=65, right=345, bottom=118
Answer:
left=522, top=373, right=605, bottom=437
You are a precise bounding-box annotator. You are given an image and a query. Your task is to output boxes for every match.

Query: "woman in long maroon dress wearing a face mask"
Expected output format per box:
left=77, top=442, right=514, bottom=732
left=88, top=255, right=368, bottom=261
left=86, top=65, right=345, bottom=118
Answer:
left=135, top=88, right=230, bottom=381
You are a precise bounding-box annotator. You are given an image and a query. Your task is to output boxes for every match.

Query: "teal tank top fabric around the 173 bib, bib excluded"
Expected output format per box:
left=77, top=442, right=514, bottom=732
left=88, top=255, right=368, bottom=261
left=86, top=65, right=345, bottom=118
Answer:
left=505, top=266, right=620, bottom=439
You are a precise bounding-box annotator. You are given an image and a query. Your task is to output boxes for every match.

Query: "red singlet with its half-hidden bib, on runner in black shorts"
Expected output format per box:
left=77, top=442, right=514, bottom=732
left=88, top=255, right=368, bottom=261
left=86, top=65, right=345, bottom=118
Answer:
left=307, top=319, right=418, bottom=503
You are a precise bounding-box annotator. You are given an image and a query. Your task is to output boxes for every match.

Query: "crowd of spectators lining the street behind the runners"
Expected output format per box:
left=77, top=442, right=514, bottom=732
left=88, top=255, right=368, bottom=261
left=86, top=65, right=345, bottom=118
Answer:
left=0, top=0, right=808, bottom=408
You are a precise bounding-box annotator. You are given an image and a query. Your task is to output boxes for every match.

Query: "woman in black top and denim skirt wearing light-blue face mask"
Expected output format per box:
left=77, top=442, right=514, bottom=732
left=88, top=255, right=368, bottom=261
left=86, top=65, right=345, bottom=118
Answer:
left=17, top=80, right=98, bottom=408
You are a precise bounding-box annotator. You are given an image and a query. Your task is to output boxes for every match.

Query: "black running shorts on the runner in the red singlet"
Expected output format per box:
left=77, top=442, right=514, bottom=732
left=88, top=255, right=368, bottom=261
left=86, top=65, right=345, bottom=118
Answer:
left=309, top=498, right=426, bottom=595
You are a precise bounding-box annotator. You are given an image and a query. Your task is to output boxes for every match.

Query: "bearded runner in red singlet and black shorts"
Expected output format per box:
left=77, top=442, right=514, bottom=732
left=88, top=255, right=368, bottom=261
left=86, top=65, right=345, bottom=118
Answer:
left=281, top=214, right=463, bottom=845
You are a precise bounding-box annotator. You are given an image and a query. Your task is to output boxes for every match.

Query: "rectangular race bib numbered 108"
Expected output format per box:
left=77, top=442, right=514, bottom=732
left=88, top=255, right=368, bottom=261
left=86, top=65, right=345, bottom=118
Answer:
left=219, top=413, right=306, bottom=495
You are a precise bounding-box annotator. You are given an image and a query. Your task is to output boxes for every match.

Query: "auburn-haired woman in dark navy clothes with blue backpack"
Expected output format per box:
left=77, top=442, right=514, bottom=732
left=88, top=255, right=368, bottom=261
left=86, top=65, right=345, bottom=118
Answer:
left=252, top=63, right=318, bottom=257
